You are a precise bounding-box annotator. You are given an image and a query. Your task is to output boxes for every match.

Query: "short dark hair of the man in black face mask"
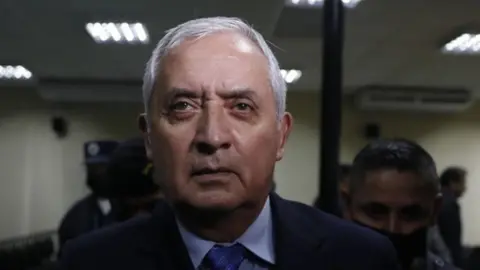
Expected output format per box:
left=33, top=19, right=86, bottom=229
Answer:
left=349, top=139, right=440, bottom=193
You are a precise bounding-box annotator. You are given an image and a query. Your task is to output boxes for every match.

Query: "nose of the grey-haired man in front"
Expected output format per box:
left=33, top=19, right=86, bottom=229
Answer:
left=194, top=106, right=231, bottom=155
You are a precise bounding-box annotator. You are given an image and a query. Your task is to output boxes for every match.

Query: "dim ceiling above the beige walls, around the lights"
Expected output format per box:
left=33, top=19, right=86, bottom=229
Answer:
left=0, top=0, right=480, bottom=94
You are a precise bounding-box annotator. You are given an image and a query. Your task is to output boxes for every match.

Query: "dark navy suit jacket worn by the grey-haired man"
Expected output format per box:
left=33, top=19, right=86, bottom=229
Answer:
left=62, top=193, right=397, bottom=270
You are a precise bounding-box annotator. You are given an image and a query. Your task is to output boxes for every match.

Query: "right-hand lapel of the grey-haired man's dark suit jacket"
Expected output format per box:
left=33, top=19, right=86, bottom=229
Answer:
left=270, top=193, right=326, bottom=270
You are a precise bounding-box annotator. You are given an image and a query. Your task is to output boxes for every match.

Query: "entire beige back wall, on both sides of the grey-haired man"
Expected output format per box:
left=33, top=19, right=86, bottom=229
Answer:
left=0, top=90, right=480, bottom=244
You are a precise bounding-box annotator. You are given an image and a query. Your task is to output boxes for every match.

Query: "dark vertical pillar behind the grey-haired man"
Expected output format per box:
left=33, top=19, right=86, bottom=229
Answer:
left=319, top=0, right=344, bottom=215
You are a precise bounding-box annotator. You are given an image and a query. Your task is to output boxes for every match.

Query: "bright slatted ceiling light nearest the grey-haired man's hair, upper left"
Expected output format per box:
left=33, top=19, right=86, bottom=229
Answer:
left=85, top=22, right=149, bottom=44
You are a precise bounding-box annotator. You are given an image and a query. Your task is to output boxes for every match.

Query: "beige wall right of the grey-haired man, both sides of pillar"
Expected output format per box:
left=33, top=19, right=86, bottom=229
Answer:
left=276, top=94, right=480, bottom=245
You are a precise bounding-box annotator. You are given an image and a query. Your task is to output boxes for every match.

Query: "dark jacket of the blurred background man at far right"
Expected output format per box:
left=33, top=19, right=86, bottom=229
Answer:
left=438, top=190, right=464, bottom=267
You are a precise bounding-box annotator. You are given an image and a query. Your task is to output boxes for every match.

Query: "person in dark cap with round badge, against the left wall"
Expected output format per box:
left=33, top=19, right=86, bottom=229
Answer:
left=58, top=141, right=118, bottom=254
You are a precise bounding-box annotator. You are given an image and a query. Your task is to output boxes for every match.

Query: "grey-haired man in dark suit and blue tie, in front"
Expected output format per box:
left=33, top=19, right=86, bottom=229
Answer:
left=62, top=17, right=396, bottom=270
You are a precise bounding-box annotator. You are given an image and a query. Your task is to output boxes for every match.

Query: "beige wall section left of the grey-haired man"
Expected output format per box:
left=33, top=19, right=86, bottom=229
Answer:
left=0, top=90, right=140, bottom=239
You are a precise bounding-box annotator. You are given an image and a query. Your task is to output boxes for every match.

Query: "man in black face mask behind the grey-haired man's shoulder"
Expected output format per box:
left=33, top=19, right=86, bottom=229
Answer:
left=344, top=139, right=455, bottom=270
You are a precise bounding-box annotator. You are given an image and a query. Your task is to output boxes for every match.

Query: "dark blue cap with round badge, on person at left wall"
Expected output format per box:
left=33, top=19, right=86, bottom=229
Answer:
left=83, top=141, right=118, bottom=164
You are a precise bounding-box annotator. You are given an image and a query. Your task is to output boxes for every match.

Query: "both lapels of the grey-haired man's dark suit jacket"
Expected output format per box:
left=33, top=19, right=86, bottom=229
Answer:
left=138, top=193, right=330, bottom=270
